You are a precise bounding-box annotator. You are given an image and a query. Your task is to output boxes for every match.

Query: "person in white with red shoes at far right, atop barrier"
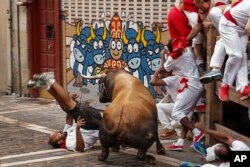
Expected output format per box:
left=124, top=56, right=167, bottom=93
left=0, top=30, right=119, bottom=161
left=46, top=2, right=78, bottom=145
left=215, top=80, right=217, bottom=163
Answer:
left=219, top=0, right=250, bottom=101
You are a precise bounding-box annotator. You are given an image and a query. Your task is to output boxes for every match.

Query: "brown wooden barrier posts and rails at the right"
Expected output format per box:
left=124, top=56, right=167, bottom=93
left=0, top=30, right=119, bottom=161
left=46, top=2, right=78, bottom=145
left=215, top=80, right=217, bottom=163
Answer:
left=205, top=22, right=250, bottom=145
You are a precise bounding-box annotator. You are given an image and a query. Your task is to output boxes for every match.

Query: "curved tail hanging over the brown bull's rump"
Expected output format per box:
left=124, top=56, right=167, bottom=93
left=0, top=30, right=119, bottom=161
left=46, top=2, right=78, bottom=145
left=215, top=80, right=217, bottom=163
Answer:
left=93, top=106, right=124, bottom=135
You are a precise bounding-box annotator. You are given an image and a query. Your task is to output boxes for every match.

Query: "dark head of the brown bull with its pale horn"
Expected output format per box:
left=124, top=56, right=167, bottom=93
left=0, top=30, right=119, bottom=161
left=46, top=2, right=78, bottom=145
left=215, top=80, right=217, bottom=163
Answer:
left=81, top=70, right=118, bottom=103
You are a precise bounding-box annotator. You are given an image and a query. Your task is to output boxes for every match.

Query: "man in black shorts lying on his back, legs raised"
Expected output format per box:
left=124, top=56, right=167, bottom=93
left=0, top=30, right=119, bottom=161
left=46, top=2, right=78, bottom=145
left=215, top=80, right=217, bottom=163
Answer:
left=28, top=72, right=102, bottom=151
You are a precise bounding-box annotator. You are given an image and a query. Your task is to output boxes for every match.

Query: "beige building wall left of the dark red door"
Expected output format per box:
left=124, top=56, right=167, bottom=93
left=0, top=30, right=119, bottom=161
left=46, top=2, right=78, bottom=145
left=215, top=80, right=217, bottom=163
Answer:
left=0, top=0, right=29, bottom=96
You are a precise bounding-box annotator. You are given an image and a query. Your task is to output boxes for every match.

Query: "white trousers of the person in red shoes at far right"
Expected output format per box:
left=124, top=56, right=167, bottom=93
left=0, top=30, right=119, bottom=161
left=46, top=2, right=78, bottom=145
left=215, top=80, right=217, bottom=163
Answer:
left=219, top=16, right=248, bottom=91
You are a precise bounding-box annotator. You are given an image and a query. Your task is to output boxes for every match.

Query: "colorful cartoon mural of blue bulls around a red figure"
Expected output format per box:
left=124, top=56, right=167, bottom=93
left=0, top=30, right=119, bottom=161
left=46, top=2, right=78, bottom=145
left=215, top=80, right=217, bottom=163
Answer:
left=69, top=13, right=164, bottom=97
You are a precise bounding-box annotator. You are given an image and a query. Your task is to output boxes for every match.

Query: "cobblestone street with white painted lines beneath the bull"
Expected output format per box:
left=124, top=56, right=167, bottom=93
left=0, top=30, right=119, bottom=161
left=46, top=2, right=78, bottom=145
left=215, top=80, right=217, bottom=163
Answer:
left=0, top=95, right=207, bottom=167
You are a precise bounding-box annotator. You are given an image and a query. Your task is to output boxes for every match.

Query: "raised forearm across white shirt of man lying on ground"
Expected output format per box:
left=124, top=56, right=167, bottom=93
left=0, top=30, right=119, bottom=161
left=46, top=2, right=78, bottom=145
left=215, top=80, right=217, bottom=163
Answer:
left=75, top=116, right=86, bottom=152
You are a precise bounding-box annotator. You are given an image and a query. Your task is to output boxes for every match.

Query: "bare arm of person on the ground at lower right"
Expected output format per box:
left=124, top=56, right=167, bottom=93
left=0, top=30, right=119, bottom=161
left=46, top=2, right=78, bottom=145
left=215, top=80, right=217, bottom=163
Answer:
left=206, top=129, right=235, bottom=146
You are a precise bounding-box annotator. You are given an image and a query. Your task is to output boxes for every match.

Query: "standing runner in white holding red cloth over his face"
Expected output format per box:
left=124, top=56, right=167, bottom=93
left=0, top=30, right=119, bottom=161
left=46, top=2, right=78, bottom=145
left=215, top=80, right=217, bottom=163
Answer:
left=152, top=38, right=204, bottom=150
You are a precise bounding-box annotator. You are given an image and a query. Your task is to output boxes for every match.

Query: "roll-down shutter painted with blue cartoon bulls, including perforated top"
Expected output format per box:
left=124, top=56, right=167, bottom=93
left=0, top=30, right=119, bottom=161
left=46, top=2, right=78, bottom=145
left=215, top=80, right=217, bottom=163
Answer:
left=61, top=0, right=174, bottom=97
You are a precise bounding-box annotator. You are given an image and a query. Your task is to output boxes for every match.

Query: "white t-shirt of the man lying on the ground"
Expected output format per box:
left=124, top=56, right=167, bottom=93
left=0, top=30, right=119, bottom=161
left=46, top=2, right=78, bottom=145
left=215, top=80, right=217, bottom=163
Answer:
left=63, top=124, right=99, bottom=151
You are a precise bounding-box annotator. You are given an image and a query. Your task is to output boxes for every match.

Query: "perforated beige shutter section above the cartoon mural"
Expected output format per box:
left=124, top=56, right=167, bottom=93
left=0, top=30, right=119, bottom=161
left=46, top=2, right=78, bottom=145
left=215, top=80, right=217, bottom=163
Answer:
left=61, top=0, right=175, bottom=27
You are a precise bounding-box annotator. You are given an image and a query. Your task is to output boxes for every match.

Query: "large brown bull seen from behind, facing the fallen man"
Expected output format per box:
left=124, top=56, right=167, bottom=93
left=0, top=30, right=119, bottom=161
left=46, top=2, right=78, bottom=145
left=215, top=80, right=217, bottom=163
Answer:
left=83, top=70, right=165, bottom=163
